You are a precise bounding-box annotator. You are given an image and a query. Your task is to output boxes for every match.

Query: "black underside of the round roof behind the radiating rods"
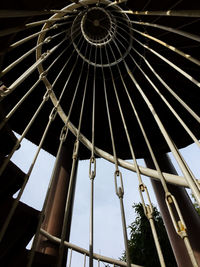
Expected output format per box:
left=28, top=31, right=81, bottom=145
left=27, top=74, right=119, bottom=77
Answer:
left=0, top=0, right=200, bottom=159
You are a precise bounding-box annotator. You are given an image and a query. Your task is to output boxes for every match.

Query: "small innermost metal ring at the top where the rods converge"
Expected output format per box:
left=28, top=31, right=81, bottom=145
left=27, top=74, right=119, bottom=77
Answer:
left=81, top=7, right=113, bottom=45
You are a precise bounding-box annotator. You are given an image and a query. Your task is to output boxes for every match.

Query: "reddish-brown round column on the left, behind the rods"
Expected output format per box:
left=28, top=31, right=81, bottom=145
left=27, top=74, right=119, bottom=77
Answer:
left=36, top=145, right=76, bottom=266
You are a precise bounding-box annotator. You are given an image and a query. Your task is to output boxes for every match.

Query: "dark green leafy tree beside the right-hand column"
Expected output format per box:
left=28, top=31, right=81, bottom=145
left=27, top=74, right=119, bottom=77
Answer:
left=121, top=203, right=177, bottom=267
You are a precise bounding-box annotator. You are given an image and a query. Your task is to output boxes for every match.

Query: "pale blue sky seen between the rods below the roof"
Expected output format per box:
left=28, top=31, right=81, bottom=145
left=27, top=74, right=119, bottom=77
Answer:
left=12, top=137, right=200, bottom=266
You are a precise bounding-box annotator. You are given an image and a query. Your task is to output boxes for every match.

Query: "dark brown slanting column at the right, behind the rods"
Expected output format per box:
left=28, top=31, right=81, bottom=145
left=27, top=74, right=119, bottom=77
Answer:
left=145, top=155, right=200, bottom=267
